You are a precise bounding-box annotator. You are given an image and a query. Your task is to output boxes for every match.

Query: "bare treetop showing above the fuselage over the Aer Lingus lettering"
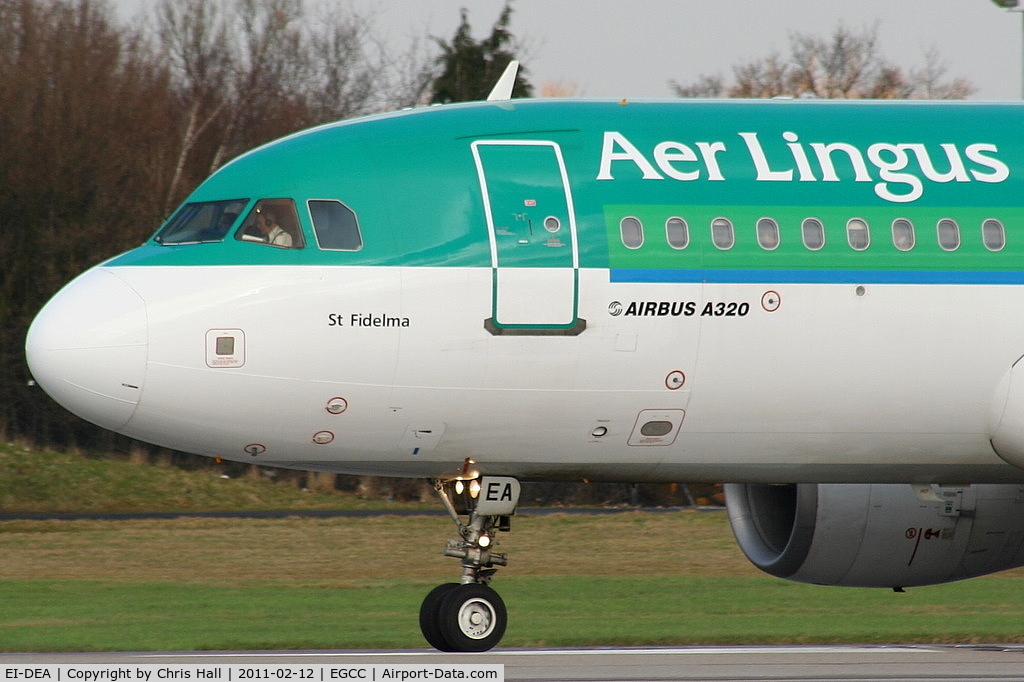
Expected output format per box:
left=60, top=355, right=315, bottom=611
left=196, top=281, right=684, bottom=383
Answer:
left=672, top=24, right=974, bottom=99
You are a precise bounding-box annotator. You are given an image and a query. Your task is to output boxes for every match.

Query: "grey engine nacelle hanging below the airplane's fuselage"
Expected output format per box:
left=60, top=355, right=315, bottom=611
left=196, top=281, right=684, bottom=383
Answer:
left=725, top=483, right=1024, bottom=588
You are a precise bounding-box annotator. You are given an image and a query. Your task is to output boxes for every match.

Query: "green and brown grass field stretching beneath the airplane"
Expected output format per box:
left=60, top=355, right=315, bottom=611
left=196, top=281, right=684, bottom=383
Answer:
left=0, top=440, right=1024, bottom=651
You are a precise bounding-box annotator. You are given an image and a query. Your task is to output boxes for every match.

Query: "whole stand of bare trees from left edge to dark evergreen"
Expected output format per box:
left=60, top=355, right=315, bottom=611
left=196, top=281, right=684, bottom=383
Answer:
left=0, top=0, right=440, bottom=445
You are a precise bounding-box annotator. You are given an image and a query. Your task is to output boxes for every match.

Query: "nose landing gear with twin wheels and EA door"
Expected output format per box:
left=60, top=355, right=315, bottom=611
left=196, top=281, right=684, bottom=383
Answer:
left=420, top=476, right=520, bottom=651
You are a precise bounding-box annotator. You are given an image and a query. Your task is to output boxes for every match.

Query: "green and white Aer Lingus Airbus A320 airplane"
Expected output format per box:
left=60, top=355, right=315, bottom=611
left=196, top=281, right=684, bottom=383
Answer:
left=26, top=61, right=1024, bottom=651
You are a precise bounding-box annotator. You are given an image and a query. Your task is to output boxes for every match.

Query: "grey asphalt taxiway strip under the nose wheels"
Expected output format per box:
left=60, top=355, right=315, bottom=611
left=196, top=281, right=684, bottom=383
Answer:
left=0, top=644, right=1024, bottom=682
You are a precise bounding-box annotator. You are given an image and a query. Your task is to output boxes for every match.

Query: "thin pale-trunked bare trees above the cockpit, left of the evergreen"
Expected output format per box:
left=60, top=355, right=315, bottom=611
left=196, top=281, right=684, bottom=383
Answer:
left=157, top=0, right=430, bottom=210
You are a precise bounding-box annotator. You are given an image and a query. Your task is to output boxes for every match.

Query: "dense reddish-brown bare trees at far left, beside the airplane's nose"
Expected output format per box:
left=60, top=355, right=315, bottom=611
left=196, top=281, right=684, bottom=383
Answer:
left=0, top=0, right=169, bottom=443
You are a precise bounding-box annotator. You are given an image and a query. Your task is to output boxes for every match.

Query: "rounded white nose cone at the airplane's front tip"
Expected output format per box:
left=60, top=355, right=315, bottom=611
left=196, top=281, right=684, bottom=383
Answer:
left=25, top=269, right=148, bottom=431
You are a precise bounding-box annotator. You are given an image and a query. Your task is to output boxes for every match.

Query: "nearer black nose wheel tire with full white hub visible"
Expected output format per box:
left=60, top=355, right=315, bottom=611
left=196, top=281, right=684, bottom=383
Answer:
left=437, top=584, right=508, bottom=651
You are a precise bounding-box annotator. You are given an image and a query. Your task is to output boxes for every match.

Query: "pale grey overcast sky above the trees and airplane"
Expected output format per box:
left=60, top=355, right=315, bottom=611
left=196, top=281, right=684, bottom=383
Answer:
left=112, top=0, right=1022, bottom=99
